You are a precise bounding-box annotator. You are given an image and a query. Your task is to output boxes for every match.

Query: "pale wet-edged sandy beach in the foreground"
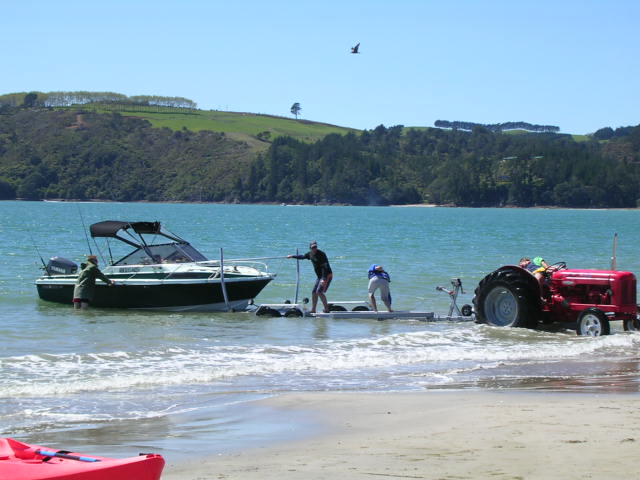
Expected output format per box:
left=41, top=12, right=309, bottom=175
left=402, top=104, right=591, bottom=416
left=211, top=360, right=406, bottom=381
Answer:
left=162, top=391, right=640, bottom=480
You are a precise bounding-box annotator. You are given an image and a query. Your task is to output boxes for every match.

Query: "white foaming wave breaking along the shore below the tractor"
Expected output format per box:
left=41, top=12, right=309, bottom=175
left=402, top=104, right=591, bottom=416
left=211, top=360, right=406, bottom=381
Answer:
left=0, top=326, right=640, bottom=398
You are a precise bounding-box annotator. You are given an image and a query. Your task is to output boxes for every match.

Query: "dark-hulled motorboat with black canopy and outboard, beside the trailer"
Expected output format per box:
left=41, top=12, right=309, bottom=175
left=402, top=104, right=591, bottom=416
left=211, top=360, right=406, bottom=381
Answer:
left=35, top=220, right=275, bottom=311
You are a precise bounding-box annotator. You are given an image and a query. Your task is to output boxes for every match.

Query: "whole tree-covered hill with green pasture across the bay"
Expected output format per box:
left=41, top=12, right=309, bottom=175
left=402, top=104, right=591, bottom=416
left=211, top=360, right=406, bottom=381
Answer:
left=0, top=92, right=640, bottom=208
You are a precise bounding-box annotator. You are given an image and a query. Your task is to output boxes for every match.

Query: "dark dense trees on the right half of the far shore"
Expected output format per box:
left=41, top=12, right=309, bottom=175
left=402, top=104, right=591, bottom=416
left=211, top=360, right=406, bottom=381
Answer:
left=237, top=125, right=640, bottom=208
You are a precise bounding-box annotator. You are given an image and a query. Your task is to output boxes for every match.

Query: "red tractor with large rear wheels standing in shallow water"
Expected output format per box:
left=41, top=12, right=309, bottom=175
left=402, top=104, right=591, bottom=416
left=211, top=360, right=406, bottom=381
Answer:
left=473, top=262, right=640, bottom=336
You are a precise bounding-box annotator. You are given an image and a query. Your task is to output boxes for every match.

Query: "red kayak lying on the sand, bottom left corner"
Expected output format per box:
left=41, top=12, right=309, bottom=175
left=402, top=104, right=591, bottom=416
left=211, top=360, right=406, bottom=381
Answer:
left=0, top=438, right=164, bottom=480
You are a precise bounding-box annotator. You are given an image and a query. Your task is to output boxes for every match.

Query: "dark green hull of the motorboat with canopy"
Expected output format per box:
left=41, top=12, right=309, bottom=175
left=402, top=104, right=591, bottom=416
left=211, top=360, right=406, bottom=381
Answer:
left=36, top=276, right=272, bottom=311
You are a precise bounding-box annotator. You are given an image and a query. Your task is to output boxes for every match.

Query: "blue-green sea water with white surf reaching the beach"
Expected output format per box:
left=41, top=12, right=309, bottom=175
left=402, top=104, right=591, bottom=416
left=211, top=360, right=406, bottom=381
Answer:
left=0, top=202, right=640, bottom=458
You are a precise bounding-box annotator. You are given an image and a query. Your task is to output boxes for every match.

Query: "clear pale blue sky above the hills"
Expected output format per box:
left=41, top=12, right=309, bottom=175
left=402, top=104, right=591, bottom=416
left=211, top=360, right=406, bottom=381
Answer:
left=0, top=0, right=640, bottom=133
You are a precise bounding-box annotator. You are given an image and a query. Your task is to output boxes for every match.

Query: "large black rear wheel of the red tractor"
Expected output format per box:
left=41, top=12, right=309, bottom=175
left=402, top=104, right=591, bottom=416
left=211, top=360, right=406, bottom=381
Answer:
left=473, top=267, right=542, bottom=328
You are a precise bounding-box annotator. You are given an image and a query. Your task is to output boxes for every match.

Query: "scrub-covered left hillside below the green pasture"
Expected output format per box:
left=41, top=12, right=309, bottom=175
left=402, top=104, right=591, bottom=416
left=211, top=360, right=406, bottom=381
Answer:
left=0, top=109, right=256, bottom=201
